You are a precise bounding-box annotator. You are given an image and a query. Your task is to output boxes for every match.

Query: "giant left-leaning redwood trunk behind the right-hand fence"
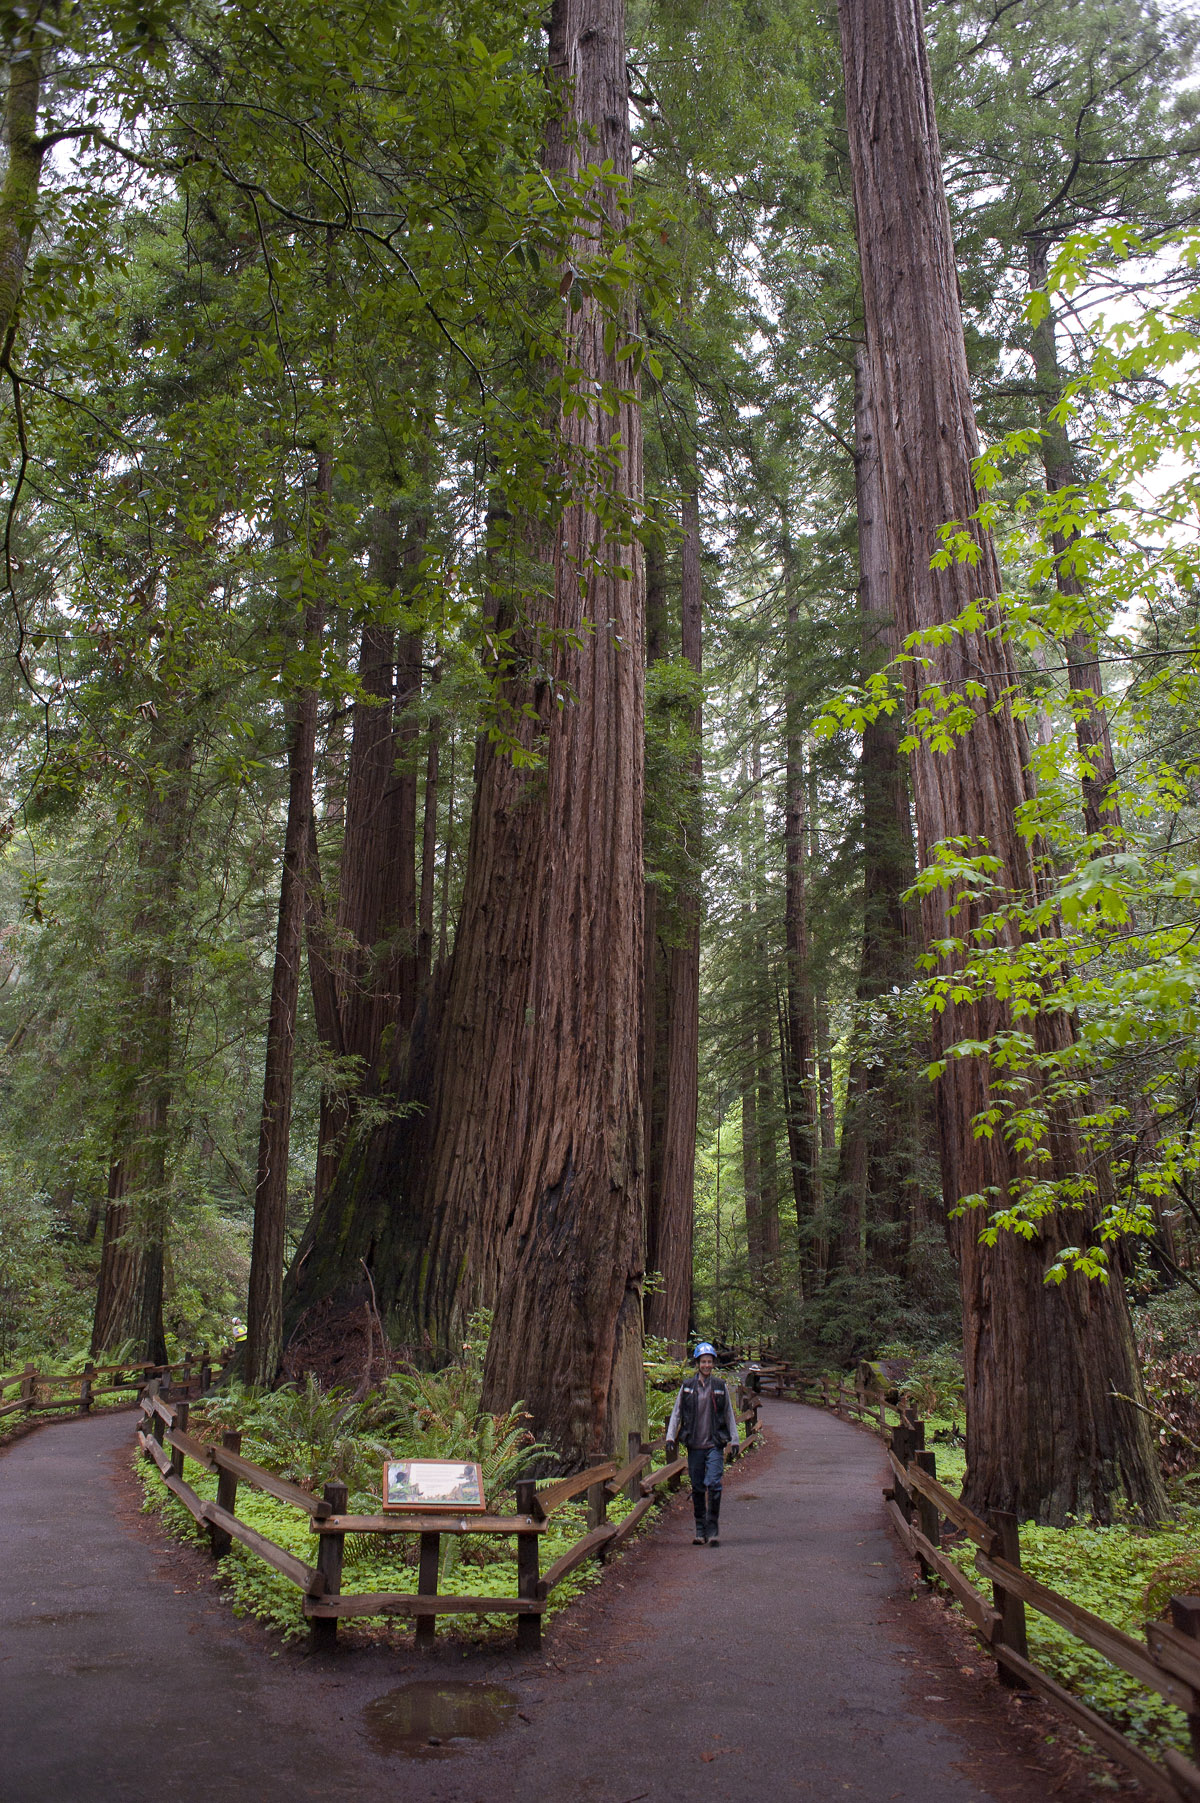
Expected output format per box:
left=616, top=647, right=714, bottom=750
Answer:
left=838, top=0, right=1166, bottom=1522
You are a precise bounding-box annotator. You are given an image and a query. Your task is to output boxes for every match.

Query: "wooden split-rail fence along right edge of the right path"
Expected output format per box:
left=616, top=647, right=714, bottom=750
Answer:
left=751, top=1359, right=1200, bottom=1803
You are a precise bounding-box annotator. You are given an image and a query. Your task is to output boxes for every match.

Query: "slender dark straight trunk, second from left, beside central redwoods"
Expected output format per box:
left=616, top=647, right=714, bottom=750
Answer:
left=245, top=472, right=333, bottom=1385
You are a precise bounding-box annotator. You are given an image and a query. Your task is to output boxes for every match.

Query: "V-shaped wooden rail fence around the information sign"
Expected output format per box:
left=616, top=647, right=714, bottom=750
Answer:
left=137, top=1381, right=759, bottom=1652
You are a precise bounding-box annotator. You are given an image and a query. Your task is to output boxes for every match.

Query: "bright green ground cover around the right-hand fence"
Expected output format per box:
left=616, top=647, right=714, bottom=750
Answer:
left=908, top=1415, right=1200, bottom=1758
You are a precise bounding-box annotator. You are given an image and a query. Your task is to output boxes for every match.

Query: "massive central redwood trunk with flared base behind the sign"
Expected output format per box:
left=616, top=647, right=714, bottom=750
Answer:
left=282, top=0, right=645, bottom=1462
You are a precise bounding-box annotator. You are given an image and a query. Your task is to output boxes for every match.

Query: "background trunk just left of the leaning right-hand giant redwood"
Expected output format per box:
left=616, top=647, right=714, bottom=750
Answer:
left=838, top=346, right=918, bottom=1271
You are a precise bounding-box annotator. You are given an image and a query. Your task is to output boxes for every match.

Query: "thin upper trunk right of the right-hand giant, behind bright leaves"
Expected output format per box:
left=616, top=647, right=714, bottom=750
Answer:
left=1027, top=236, right=1121, bottom=844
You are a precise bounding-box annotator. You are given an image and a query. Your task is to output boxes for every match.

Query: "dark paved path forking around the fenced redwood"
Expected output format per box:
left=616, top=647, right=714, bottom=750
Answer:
left=0, top=1403, right=1085, bottom=1803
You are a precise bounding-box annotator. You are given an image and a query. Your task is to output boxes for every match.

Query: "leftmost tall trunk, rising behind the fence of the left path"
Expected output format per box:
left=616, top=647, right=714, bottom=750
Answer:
left=92, top=717, right=193, bottom=1363
